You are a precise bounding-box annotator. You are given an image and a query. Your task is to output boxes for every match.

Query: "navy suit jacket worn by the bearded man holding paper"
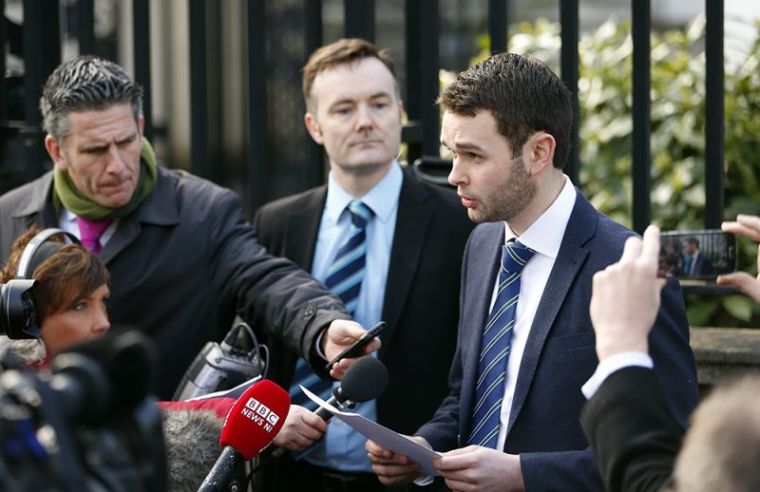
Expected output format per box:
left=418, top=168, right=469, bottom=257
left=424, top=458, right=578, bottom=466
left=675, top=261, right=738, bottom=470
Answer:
left=417, top=193, right=698, bottom=491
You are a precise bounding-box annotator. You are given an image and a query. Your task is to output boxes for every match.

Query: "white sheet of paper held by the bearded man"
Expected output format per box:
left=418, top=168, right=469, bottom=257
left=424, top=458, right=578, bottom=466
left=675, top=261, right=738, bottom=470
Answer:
left=299, top=385, right=440, bottom=476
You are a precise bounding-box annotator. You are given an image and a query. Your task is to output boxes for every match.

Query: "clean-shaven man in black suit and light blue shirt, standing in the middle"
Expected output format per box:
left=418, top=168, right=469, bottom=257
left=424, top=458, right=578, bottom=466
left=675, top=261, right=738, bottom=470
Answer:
left=254, top=39, right=472, bottom=491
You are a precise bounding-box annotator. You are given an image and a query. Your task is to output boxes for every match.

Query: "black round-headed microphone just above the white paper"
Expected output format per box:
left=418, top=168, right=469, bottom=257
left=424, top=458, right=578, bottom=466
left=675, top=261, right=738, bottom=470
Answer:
left=314, top=355, right=388, bottom=421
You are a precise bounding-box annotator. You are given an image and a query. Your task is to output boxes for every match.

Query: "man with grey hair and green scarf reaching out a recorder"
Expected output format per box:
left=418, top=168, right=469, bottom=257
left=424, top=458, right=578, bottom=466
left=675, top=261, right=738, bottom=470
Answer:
left=0, top=56, right=377, bottom=399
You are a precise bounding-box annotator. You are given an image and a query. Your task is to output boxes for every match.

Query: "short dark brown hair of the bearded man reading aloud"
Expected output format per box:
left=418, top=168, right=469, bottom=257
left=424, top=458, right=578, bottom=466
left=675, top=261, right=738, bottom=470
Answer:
left=438, top=53, right=573, bottom=169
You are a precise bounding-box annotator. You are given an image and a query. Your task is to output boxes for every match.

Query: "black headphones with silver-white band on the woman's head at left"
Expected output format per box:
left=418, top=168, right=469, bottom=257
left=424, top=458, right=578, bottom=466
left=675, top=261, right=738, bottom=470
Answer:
left=0, top=228, right=80, bottom=339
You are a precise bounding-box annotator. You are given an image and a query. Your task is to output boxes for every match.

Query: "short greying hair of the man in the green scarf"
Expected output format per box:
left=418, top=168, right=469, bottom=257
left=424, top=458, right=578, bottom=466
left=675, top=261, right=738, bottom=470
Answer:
left=40, top=55, right=143, bottom=142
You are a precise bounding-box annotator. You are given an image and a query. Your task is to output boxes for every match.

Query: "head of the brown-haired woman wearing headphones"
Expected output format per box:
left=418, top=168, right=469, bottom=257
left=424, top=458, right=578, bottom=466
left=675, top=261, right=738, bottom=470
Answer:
left=0, top=226, right=111, bottom=366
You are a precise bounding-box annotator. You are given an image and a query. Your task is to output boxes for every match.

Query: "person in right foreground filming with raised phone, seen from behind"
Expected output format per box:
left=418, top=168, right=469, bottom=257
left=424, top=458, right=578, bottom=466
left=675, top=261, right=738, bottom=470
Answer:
left=581, top=219, right=760, bottom=492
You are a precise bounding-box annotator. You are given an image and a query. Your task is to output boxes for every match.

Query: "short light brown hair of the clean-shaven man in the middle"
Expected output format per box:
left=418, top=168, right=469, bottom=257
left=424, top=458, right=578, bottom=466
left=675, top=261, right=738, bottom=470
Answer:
left=301, top=38, right=398, bottom=110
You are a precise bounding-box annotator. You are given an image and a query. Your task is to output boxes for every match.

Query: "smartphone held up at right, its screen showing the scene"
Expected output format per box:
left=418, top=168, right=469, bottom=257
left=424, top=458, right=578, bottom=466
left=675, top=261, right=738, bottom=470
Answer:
left=658, top=229, right=736, bottom=281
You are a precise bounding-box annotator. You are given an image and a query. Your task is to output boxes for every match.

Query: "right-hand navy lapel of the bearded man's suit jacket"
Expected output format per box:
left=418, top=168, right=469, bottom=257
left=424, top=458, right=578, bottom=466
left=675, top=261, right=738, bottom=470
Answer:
left=507, top=192, right=598, bottom=433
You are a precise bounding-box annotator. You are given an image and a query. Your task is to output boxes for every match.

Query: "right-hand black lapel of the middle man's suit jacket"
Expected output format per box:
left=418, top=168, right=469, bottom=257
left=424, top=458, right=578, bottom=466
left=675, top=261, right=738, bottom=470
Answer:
left=380, top=173, right=433, bottom=355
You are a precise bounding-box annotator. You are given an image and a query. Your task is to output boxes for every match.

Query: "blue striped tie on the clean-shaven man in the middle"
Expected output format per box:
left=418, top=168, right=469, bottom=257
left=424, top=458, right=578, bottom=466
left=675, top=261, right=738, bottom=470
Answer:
left=290, top=200, right=373, bottom=409
